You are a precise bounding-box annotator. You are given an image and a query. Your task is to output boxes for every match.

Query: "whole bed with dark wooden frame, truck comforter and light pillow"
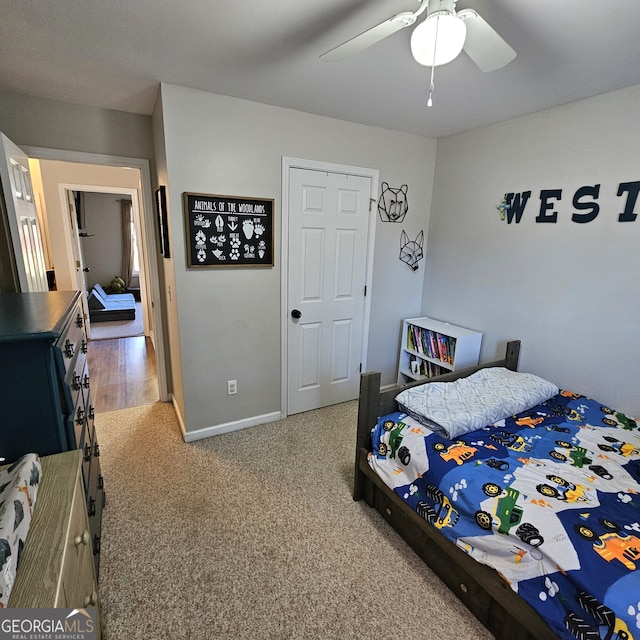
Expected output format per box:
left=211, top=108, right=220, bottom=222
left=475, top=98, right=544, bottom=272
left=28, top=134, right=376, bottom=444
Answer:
left=353, top=341, right=640, bottom=640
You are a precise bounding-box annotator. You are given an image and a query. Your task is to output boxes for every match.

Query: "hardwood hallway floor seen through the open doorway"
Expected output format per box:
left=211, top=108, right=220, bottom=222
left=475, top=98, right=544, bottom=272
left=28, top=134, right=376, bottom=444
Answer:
left=87, top=336, right=159, bottom=413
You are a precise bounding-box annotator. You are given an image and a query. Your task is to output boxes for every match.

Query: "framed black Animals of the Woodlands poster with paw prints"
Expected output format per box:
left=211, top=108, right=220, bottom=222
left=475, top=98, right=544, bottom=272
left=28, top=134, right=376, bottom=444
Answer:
left=183, top=192, right=274, bottom=269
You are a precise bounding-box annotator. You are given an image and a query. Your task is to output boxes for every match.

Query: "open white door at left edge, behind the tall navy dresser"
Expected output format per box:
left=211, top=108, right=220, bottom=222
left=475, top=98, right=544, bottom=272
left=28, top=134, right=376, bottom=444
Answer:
left=0, top=133, right=49, bottom=292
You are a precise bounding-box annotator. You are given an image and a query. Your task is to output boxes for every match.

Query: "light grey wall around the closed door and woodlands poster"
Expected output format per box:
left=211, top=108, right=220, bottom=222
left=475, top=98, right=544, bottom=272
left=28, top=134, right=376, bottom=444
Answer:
left=154, top=85, right=436, bottom=431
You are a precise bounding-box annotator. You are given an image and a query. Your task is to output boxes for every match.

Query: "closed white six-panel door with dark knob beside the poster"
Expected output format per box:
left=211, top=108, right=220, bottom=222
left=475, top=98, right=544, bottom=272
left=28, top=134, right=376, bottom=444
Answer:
left=287, top=168, right=371, bottom=414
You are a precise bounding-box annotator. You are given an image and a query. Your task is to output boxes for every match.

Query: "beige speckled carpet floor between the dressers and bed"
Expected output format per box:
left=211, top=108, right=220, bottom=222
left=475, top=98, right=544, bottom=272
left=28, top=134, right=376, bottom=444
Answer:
left=96, top=402, right=493, bottom=640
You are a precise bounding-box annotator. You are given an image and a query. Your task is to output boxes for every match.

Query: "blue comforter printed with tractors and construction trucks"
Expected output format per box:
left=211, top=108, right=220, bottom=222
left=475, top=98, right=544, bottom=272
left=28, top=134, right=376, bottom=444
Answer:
left=369, top=391, right=640, bottom=640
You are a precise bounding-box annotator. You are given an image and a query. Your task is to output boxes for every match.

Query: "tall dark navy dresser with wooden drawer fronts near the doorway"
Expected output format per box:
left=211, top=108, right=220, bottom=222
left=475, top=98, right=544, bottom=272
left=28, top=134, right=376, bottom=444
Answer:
left=0, top=291, right=105, bottom=575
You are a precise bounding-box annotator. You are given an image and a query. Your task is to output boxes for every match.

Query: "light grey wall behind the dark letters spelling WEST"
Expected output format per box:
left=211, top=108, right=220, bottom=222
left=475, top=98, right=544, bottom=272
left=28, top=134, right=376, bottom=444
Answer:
left=422, top=86, right=640, bottom=415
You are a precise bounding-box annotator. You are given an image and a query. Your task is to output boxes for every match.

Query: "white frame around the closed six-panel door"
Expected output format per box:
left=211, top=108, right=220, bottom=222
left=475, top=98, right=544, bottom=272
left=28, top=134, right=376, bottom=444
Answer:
left=280, top=156, right=380, bottom=418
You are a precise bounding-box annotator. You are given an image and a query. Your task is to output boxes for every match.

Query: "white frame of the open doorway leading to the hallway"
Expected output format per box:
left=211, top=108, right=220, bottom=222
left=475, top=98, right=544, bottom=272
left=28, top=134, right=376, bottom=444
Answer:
left=21, top=145, right=171, bottom=402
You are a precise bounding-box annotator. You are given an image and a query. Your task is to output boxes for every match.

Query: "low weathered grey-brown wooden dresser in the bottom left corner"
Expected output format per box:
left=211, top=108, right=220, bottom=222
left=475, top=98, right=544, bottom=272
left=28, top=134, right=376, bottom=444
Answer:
left=8, top=450, right=102, bottom=638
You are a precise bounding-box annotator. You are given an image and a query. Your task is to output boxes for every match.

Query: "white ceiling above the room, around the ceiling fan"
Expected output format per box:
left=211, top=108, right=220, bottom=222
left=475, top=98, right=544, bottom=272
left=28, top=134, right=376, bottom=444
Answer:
left=0, top=0, right=640, bottom=137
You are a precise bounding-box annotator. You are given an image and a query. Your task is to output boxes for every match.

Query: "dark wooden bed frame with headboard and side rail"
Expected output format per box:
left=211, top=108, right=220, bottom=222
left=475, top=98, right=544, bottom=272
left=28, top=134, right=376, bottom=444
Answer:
left=353, top=340, right=558, bottom=640
